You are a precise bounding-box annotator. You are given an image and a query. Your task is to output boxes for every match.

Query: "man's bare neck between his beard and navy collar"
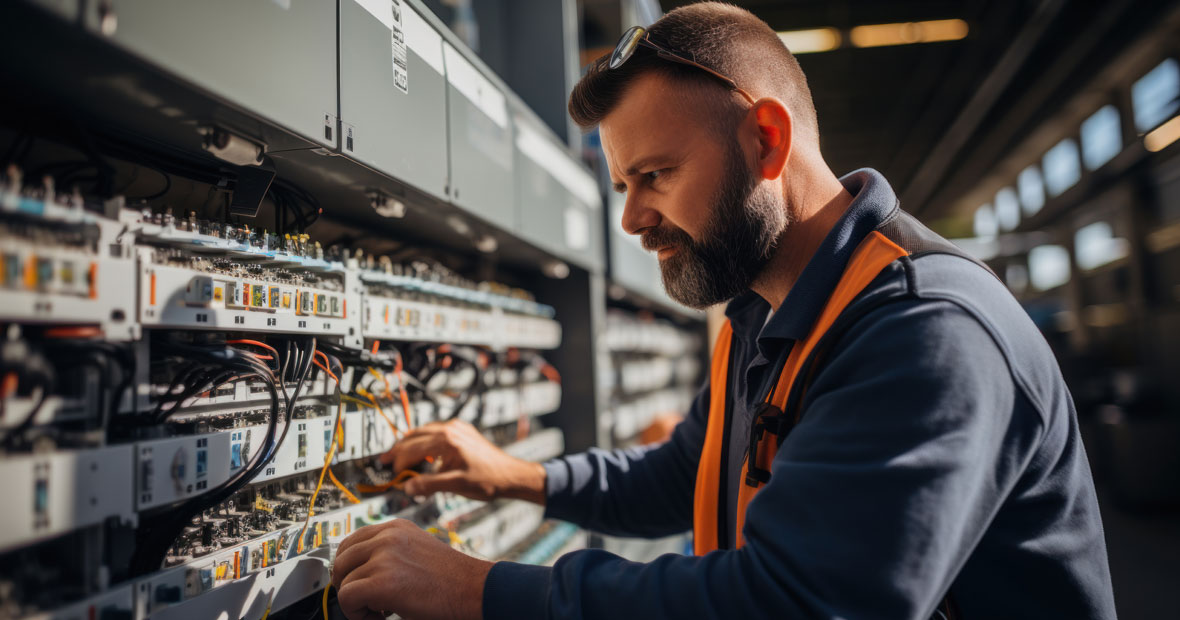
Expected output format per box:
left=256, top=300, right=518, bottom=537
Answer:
left=750, top=170, right=852, bottom=312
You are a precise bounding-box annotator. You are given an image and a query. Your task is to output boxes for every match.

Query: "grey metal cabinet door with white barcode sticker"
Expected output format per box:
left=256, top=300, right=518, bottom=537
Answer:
left=340, top=0, right=447, bottom=198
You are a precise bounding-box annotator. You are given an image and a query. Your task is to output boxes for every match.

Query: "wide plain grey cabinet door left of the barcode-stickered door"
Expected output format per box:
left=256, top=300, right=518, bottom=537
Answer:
left=86, top=0, right=337, bottom=148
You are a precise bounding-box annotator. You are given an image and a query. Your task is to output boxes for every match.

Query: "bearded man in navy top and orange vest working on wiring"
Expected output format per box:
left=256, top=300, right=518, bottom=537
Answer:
left=333, top=4, right=1115, bottom=620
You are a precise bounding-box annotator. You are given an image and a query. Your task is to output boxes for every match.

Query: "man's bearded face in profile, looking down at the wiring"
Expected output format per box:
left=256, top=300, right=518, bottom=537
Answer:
left=601, top=74, right=788, bottom=308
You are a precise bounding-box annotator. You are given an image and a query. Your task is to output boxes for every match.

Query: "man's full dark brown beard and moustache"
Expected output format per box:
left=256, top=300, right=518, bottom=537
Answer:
left=642, top=142, right=789, bottom=308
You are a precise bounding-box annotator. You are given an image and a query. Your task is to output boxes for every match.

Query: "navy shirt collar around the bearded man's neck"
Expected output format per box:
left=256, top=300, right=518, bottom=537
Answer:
left=726, top=168, right=898, bottom=355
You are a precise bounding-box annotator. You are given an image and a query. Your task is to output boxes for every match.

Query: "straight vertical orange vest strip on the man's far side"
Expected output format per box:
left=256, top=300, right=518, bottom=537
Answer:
left=693, top=320, right=734, bottom=555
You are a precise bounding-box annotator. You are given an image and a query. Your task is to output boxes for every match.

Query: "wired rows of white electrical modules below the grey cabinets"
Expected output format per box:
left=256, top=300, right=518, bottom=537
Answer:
left=0, top=169, right=585, bottom=620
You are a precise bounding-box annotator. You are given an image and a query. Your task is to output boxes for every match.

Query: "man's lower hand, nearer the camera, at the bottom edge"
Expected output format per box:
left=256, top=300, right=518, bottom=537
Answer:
left=332, top=518, right=492, bottom=620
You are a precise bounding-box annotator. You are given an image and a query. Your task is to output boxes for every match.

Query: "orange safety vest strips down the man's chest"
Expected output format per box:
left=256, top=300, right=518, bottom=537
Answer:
left=693, top=230, right=909, bottom=555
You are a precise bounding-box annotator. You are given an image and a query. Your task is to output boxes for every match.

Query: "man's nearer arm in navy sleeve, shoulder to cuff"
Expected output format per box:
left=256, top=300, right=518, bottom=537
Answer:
left=483, top=297, right=1042, bottom=618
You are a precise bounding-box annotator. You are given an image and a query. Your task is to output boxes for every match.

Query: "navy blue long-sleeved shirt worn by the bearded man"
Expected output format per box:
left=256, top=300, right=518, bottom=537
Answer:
left=483, top=170, right=1115, bottom=620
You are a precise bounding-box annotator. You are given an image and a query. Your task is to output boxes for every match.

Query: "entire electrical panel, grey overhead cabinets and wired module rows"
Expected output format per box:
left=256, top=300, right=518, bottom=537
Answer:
left=0, top=0, right=697, bottom=620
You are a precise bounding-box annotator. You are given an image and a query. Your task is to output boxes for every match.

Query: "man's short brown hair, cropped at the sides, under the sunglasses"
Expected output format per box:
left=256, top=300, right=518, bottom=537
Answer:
left=569, top=2, right=819, bottom=146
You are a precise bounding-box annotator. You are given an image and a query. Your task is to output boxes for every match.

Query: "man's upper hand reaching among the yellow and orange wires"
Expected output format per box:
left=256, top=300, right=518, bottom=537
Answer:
left=381, top=419, right=545, bottom=504
